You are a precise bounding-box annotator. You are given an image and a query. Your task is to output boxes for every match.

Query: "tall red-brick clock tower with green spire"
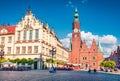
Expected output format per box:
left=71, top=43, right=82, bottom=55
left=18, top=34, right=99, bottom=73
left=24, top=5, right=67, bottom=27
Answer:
left=72, top=9, right=81, bottom=64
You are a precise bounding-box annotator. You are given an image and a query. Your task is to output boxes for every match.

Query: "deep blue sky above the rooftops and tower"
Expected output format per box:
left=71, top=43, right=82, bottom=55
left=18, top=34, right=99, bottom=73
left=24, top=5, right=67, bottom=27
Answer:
left=0, top=0, right=120, bottom=56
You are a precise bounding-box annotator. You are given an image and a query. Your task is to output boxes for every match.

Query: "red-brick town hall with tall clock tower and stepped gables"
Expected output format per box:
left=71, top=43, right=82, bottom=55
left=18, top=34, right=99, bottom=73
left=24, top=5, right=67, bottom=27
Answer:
left=69, top=9, right=103, bottom=69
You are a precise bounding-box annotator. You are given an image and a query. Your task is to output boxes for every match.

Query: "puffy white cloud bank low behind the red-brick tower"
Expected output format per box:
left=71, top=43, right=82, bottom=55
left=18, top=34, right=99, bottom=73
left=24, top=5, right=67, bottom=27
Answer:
left=60, top=31, right=117, bottom=56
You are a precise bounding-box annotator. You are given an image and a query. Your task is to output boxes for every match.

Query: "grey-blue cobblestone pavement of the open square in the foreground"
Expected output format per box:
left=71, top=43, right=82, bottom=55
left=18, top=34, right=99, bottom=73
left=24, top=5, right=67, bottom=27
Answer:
left=0, top=70, right=120, bottom=81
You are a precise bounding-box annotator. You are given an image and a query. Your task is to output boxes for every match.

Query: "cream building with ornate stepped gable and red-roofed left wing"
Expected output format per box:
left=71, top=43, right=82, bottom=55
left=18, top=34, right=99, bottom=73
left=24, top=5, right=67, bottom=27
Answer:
left=0, top=9, right=69, bottom=69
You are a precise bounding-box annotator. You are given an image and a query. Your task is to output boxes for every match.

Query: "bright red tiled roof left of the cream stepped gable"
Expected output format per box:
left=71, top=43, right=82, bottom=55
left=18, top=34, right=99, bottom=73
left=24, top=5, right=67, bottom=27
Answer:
left=0, top=25, right=16, bottom=35
